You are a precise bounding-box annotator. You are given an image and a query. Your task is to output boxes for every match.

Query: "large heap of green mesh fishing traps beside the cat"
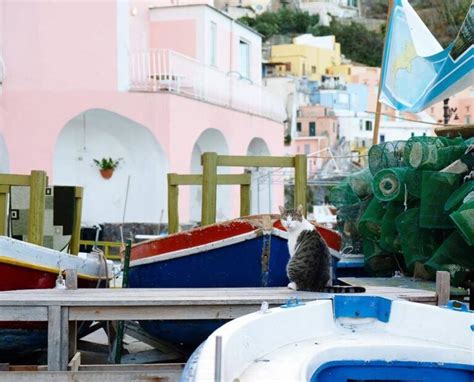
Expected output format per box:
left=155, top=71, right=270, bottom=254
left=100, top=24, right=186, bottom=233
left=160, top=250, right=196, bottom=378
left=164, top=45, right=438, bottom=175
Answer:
left=331, top=136, right=474, bottom=285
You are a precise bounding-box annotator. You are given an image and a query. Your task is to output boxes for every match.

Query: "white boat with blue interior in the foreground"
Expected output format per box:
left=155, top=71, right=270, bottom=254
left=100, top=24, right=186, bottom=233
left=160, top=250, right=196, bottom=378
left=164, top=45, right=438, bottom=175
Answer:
left=182, top=295, right=474, bottom=382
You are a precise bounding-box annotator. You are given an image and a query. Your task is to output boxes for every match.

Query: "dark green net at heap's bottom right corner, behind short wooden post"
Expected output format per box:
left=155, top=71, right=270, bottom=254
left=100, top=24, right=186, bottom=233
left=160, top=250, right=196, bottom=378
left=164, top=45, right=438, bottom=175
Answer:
left=425, top=231, right=474, bottom=286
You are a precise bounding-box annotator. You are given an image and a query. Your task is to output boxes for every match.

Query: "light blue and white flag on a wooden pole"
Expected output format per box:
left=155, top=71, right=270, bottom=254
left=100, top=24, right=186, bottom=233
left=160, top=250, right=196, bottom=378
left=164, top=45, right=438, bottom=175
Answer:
left=380, top=0, right=474, bottom=112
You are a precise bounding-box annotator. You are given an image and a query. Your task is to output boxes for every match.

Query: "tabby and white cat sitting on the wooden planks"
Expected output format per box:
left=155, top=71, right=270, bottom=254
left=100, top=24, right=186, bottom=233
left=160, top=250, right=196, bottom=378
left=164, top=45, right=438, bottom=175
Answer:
left=279, top=205, right=365, bottom=293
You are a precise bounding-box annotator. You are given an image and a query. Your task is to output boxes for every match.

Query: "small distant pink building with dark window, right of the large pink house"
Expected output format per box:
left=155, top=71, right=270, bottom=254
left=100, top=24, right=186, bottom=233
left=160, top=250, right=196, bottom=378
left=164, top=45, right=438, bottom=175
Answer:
left=292, top=105, right=338, bottom=175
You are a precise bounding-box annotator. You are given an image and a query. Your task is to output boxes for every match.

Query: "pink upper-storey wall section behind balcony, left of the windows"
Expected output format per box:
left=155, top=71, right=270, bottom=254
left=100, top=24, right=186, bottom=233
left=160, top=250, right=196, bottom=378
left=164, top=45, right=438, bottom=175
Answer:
left=150, top=20, right=197, bottom=58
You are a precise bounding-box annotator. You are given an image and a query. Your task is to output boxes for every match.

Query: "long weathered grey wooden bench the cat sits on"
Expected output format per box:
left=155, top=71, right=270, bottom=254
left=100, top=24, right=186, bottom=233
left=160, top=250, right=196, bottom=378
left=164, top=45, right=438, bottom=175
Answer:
left=0, top=287, right=436, bottom=371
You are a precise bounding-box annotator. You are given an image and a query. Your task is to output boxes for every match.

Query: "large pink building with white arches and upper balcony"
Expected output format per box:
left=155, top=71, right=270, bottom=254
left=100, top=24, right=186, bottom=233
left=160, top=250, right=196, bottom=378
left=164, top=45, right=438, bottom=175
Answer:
left=0, top=0, right=285, bottom=223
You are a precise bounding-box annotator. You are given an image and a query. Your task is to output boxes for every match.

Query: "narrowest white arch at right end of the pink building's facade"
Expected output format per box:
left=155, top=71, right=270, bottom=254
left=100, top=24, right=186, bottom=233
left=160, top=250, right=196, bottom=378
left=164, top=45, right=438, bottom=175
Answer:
left=247, top=138, right=272, bottom=214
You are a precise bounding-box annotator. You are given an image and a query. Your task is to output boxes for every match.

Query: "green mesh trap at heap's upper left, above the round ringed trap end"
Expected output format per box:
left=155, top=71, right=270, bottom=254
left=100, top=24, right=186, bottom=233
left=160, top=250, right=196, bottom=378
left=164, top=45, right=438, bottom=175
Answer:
left=369, top=141, right=405, bottom=175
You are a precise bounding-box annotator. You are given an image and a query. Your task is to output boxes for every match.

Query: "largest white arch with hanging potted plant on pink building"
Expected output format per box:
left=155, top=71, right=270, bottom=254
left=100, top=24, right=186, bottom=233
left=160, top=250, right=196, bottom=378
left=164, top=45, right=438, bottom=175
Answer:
left=53, top=109, right=168, bottom=223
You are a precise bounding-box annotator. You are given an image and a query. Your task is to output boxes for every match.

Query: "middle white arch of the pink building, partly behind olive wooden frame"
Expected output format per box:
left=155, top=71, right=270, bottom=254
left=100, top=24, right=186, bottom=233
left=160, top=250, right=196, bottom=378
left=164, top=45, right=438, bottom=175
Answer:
left=189, top=128, right=232, bottom=222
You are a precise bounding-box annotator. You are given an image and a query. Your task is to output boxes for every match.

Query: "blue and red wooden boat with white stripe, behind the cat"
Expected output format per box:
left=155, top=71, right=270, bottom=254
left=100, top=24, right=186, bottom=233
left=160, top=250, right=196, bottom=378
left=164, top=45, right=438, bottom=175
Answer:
left=129, top=215, right=341, bottom=350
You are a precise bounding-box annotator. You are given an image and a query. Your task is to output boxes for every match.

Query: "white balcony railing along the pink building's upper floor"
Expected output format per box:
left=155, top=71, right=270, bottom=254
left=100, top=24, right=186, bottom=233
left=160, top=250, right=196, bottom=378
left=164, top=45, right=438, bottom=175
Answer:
left=130, top=49, right=286, bottom=122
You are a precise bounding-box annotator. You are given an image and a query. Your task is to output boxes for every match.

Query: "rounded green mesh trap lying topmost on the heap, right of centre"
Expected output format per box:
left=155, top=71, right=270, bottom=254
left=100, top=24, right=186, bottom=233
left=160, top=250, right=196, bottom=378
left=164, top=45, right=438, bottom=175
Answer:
left=403, top=136, right=467, bottom=170
